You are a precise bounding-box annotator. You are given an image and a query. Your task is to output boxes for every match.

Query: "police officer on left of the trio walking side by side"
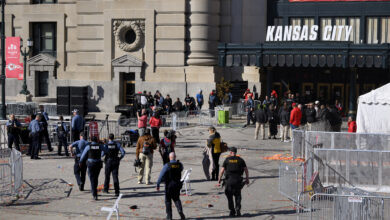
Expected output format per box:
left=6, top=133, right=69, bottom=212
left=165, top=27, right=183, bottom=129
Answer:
left=69, top=133, right=89, bottom=191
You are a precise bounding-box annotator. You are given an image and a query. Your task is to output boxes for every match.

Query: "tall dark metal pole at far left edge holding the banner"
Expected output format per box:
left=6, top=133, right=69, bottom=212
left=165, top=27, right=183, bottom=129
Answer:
left=0, top=0, right=6, bottom=120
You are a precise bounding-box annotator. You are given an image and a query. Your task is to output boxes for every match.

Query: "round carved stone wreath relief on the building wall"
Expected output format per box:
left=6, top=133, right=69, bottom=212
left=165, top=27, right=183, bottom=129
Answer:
left=113, top=19, right=145, bottom=52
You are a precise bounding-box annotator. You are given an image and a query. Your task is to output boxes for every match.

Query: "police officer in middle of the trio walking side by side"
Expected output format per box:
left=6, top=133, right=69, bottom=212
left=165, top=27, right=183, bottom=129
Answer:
left=80, top=136, right=106, bottom=200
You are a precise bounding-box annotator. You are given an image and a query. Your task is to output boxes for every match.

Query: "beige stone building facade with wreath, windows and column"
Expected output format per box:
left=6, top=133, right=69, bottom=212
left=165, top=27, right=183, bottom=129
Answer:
left=5, top=0, right=267, bottom=112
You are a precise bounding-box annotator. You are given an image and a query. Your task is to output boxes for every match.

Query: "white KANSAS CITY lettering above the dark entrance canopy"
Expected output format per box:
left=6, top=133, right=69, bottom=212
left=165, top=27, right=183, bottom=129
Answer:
left=266, top=25, right=352, bottom=41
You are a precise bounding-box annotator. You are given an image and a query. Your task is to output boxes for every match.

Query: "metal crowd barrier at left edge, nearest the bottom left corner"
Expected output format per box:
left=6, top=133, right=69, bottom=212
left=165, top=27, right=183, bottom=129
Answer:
left=0, top=148, right=23, bottom=202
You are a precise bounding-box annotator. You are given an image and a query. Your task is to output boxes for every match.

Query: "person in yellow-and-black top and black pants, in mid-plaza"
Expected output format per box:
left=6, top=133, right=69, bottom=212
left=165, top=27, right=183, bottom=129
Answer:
left=207, top=127, right=221, bottom=180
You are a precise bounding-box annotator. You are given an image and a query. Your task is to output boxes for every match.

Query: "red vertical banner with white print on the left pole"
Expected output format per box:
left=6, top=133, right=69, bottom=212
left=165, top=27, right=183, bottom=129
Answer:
left=5, top=37, right=23, bottom=80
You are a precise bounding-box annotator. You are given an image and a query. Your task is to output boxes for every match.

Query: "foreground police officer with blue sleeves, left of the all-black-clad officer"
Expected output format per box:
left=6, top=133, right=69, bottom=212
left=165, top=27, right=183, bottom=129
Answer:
left=157, top=152, right=186, bottom=220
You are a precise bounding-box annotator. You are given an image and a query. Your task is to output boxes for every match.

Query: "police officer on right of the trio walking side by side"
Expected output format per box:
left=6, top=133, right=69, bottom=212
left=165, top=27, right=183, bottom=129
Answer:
left=103, top=134, right=125, bottom=196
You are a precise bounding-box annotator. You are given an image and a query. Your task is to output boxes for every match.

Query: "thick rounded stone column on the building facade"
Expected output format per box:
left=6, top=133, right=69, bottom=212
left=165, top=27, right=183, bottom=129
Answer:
left=187, top=0, right=220, bottom=66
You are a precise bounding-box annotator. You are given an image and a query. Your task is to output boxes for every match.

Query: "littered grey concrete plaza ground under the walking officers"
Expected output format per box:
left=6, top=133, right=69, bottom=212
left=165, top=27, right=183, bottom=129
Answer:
left=0, top=126, right=296, bottom=219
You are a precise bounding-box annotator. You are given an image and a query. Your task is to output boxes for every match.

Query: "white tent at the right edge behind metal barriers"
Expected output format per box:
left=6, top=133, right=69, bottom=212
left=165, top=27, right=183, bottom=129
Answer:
left=356, top=83, right=390, bottom=134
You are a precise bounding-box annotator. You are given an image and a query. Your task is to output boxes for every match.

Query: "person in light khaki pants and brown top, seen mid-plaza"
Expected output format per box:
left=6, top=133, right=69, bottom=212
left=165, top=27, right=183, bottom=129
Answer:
left=135, top=128, right=157, bottom=185
